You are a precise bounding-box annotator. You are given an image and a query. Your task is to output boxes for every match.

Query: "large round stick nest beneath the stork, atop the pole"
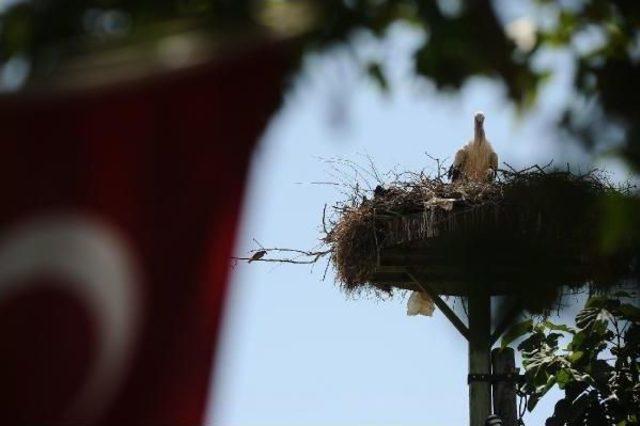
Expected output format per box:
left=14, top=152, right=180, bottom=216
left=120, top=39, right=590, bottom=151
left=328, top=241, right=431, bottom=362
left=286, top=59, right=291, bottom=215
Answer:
left=325, top=166, right=640, bottom=308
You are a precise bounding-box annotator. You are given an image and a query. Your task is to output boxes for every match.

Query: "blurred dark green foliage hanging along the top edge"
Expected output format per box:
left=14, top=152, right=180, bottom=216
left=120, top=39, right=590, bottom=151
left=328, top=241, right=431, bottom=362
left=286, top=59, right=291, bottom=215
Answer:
left=0, top=0, right=640, bottom=170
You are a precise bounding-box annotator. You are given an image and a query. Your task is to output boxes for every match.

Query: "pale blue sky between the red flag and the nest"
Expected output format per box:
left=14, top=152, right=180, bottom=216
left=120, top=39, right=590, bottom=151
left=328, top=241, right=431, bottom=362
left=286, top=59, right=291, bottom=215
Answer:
left=208, top=7, right=624, bottom=426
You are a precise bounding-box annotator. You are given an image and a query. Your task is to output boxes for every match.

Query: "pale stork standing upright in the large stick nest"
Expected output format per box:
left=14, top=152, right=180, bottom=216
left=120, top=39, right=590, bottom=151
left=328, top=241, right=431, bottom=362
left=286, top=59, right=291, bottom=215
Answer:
left=447, top=112, right=498, bottom=183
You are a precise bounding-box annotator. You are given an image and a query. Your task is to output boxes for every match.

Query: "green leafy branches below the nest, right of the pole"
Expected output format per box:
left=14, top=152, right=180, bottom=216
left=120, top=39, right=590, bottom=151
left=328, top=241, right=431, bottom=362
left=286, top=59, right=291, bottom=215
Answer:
left=503, top=293, right=640, bottom=426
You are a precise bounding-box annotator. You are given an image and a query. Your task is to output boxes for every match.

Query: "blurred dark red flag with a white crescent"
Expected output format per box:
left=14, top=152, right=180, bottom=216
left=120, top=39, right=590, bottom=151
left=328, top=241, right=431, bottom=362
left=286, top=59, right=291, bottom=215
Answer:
left=0, top=38, right=285, bottom=426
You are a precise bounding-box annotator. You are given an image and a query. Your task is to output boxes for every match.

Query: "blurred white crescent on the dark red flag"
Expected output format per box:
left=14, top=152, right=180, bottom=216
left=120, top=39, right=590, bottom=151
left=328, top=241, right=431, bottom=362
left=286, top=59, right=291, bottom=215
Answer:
left=0, top=214, right=142, bottom=424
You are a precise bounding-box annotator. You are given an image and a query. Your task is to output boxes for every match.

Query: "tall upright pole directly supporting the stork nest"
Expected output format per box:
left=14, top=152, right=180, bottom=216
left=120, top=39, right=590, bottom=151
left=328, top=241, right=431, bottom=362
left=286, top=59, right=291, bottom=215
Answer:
left=469, top=288, right=491, bottom=426
